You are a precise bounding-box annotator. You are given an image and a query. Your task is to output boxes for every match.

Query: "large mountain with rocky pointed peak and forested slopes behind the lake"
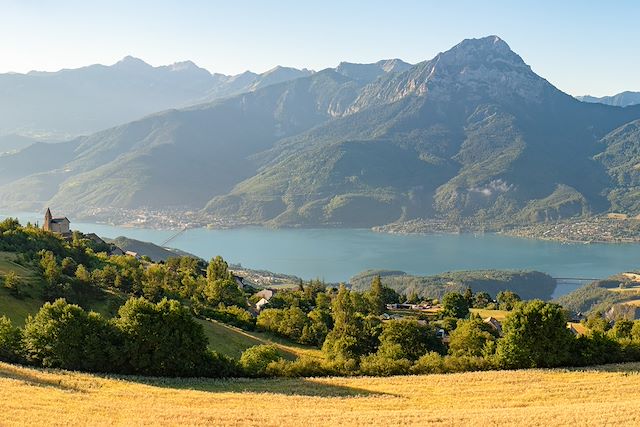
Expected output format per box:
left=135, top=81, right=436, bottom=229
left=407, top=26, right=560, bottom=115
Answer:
left=0, top=36, right=640, bottom=231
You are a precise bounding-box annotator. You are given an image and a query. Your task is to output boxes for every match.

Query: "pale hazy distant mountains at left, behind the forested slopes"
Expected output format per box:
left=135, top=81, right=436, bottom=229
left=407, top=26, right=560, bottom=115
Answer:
left=0, top=56, right=311, bottom=139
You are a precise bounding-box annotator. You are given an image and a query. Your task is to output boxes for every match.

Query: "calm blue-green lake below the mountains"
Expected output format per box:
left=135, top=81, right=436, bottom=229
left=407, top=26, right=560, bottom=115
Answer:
left=0, top=213, right=640, bottom=296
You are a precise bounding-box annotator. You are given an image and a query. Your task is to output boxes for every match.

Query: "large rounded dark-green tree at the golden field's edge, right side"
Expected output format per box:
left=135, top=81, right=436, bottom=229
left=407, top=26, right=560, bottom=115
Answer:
left=496, top=300, right=574, bottom=368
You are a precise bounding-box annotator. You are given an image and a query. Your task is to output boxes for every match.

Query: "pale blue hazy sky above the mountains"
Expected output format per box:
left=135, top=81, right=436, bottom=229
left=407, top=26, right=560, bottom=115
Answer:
left=0, top=0, right=640, bottom=95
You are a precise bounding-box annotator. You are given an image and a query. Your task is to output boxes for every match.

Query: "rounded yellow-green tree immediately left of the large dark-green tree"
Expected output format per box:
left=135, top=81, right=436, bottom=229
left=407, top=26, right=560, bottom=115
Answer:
left=449, top=317, right=496, bottom=356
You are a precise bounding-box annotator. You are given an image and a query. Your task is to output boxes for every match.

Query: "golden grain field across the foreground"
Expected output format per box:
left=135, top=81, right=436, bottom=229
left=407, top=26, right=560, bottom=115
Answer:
left=0, top=363, right=640, bottom=426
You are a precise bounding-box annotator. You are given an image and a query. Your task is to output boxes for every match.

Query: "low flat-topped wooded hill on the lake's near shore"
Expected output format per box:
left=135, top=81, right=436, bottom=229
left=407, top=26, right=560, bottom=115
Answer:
left=349, top=270, right=556, bottom=300
